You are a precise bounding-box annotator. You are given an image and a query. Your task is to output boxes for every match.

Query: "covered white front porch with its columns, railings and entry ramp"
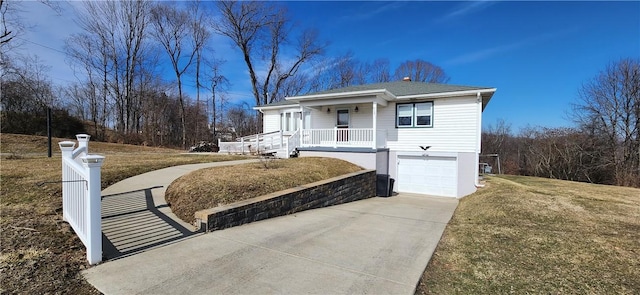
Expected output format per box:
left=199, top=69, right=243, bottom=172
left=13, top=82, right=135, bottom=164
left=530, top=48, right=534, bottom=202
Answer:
left=219, top=90, right=393, bottom=157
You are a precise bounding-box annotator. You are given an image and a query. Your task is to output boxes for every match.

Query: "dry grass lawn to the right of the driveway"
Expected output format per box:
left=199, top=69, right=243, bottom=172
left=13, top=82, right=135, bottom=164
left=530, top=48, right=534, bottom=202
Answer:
left=416, top=176, right=640, bottom=294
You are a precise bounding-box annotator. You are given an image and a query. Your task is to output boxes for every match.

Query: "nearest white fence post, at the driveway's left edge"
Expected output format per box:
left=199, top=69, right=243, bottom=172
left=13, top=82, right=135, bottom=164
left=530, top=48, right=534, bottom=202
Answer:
left=81, top=155, right=104, bottom=264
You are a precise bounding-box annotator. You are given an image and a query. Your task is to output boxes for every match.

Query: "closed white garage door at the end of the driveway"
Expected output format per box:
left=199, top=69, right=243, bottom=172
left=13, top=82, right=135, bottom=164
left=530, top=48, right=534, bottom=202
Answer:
left=396, top=156, right=458, bottom=197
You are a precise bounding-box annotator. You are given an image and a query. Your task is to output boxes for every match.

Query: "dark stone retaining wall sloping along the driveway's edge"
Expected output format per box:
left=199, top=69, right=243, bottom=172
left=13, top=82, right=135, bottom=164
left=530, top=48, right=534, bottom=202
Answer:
left=195, top=170, right=376, bottom=231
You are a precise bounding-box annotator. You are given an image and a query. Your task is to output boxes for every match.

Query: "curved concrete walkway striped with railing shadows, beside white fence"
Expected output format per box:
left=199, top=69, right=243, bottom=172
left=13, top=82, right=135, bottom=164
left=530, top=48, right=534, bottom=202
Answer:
left=102, top=160, right=257, bottom=260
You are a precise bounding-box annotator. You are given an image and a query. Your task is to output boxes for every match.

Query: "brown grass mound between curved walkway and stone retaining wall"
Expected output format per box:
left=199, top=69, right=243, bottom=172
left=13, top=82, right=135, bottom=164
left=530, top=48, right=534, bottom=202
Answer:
left=165, top=157, right=362, bottom=223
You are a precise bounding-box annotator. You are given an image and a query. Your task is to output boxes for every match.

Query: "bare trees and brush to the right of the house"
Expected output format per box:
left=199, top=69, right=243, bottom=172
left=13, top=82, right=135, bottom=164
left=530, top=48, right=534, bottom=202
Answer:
left=482, top=58, right=640, bottom=187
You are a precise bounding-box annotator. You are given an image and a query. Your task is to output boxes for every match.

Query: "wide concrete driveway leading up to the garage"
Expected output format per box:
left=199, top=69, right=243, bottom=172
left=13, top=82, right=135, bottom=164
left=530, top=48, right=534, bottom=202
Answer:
left=83, top=194, right=458, bottom=294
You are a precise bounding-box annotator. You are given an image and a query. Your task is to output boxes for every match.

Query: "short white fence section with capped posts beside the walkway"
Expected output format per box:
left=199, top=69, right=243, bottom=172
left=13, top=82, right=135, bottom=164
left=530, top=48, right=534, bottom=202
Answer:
left=59, top=134, right=104, bottom=264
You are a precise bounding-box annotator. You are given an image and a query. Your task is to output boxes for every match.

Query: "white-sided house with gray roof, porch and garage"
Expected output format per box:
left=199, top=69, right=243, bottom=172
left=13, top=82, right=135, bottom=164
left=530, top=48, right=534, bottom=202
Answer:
left=248, top=81, right=496, bottom=197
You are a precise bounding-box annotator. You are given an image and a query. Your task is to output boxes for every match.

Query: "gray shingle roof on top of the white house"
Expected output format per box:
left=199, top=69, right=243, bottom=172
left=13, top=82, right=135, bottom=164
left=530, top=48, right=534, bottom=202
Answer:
left=305, top=81, right=492, bottom=96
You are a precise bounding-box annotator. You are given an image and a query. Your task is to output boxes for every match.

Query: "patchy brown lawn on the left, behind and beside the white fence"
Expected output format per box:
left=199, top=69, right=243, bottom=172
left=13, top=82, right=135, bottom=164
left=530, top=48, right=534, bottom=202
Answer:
left=0, top=133, right=246, bottom=294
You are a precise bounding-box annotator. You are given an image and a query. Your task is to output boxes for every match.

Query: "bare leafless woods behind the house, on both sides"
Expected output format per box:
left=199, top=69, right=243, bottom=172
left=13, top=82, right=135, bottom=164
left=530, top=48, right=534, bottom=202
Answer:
left=0, top=0, right=640, bottom=187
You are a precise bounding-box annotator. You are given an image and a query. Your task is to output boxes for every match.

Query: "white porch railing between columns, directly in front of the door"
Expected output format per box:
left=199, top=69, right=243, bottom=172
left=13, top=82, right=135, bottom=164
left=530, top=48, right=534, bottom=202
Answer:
left=301, top=128, right=387, bottom=148
